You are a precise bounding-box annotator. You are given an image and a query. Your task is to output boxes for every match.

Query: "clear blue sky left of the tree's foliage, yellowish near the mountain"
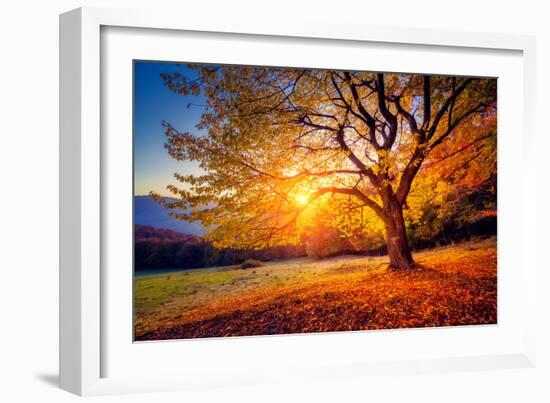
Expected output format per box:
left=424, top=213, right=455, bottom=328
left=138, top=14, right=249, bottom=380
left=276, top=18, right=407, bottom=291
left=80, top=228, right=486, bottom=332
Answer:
left=134, top=61, right=206, bottom=195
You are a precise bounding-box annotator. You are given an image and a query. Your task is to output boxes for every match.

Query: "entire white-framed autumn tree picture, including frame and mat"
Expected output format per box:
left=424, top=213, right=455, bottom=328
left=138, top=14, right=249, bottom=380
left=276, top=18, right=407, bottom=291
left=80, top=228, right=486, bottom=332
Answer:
left=60, top=9, right=536, bottom=394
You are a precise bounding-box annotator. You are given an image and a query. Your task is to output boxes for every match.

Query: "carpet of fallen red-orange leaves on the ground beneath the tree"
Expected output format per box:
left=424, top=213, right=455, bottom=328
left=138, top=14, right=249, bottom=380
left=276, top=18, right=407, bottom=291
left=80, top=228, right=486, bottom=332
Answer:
left=136, top=246, right=497, bottom=340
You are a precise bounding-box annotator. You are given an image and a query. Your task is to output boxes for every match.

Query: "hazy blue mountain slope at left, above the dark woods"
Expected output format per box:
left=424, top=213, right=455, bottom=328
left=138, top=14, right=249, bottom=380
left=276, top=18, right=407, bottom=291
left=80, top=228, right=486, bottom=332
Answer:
left=134, top=196, right=204, bottom=235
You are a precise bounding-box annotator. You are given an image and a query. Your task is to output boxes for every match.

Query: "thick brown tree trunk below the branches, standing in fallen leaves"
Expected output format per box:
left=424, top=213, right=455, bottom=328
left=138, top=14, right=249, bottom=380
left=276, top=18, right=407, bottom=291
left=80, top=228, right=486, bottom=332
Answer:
left=384, top=201, right=414, bottom=269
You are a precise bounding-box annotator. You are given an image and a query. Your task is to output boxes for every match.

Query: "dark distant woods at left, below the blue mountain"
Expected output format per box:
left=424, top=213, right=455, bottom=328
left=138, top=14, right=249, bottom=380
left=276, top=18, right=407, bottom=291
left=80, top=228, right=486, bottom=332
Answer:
left=134, top=224, right=306, bottom=270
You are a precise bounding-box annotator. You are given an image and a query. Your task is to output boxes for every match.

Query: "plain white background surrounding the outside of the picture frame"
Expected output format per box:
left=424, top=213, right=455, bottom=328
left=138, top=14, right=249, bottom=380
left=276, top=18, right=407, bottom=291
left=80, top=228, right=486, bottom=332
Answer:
left=0, top=0, right=550, bottom=403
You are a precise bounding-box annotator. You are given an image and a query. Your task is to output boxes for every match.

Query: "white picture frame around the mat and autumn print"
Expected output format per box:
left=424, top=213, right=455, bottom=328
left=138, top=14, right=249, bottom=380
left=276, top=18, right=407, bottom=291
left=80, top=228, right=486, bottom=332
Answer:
left=60, top=8, right=537, bottom=395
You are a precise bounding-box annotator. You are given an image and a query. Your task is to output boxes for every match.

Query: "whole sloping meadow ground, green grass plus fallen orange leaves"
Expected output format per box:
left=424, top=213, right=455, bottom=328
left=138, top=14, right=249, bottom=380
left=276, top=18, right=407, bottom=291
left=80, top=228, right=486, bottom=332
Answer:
left=135, top=238, right=497, bottom=340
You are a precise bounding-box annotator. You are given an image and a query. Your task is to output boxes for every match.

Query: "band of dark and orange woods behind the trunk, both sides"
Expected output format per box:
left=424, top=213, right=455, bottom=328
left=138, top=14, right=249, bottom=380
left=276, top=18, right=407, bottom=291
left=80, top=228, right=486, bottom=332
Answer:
left=134, top=182, right=497, bottom=270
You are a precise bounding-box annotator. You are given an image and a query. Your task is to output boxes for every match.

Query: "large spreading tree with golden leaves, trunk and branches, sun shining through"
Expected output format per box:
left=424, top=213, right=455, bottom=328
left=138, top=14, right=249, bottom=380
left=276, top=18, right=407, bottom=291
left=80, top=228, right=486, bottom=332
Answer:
left=154, top=65, right=496, bottom=269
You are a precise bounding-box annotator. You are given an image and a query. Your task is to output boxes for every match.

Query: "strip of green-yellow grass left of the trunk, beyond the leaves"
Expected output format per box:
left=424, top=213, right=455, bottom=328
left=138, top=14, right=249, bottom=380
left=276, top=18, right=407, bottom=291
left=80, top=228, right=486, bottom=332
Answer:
left=134, top=256, right=378, bottom=328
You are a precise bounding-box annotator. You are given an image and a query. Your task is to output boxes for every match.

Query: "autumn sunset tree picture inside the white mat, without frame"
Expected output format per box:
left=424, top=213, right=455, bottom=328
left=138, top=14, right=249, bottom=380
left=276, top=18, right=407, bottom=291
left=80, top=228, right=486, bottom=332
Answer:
left=134, top=60, right=504, bottom=342
